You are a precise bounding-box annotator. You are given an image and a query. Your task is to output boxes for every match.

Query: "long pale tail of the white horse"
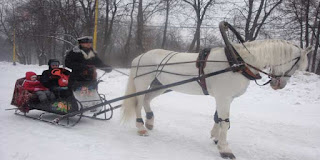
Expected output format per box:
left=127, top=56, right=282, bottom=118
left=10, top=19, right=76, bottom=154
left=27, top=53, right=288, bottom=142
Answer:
left=121, top=69, right=138, bottom=122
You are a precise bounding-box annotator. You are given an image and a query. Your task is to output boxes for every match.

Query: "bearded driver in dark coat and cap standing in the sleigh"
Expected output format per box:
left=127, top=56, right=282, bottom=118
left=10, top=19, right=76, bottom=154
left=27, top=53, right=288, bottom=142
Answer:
left=65, top=36, right=112, bottom=88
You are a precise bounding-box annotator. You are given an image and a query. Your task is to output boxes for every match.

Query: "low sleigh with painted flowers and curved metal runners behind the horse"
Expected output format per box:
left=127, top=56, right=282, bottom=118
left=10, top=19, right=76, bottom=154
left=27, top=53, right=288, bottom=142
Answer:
left=11, top=76, right=113, bottom=126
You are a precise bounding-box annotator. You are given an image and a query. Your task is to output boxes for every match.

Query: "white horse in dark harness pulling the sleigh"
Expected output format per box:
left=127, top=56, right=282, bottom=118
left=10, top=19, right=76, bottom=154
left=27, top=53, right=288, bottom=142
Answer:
left=122, top=40, right=311, bottom=159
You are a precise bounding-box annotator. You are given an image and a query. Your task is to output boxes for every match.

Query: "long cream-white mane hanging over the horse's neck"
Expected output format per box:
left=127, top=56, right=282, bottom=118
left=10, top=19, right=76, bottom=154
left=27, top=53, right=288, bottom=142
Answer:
left=234, top=40, right=302, bottom=72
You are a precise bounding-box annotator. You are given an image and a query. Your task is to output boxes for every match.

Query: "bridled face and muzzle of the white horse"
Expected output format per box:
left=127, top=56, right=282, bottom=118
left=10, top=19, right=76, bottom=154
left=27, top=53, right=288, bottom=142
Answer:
left=270, top=46, right=312, bottom=90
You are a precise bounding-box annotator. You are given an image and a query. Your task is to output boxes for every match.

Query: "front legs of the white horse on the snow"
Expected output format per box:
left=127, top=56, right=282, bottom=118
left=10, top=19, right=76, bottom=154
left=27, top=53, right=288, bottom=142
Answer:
left=213, top=97, right=236, bottom=159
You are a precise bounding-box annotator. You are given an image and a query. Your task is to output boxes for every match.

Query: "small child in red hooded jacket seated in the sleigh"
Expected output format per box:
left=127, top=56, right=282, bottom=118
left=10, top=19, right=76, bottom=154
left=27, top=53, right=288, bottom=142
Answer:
left=22, top=72, right=55, bottom=103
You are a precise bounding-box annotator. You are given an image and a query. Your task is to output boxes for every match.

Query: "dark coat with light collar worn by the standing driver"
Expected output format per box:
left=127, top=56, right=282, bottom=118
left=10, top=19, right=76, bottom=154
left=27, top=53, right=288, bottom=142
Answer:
left=65, top=46, right=112, bottom=86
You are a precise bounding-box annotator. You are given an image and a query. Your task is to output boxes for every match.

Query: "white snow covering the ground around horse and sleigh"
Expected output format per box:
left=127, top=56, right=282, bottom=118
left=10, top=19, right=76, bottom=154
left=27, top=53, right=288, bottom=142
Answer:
left=0, top=62, right=320, bottom=160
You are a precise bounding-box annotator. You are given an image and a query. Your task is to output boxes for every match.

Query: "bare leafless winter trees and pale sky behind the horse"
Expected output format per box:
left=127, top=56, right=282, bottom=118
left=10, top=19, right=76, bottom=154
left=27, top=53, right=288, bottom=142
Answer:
left=0, top=0, right=320, bottom=75
